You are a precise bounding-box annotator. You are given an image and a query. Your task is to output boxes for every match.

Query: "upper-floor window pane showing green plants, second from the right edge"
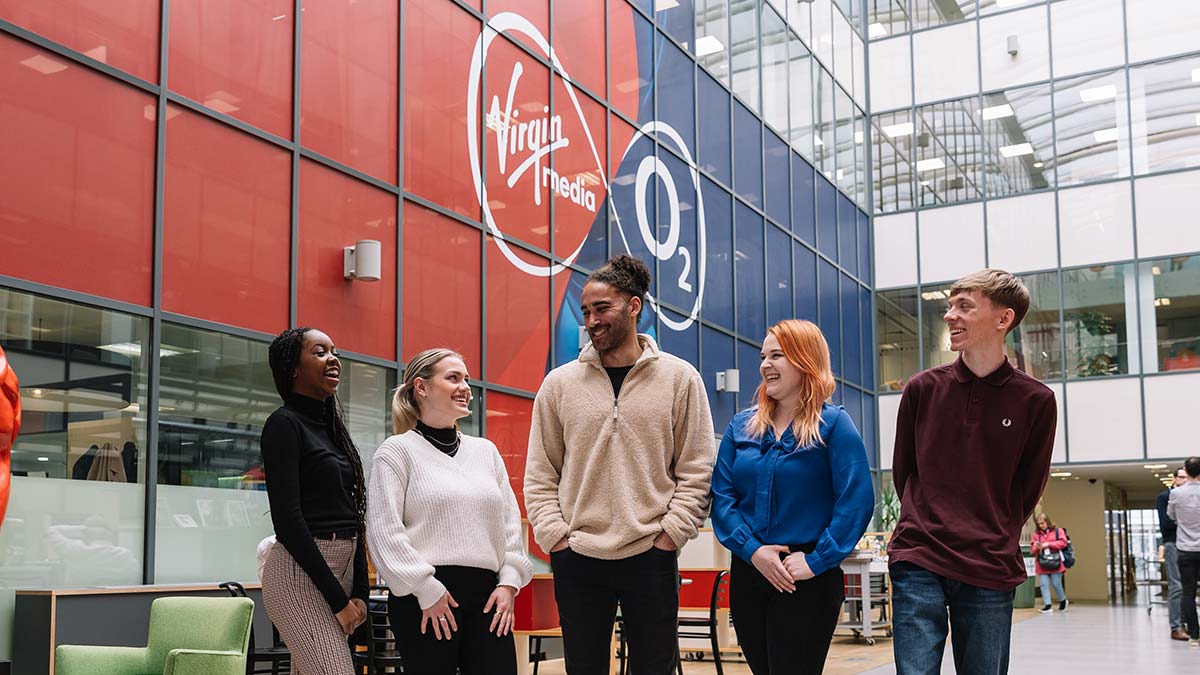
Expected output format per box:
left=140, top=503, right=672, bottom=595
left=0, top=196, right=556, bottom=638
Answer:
left=1062, top=264, right=1138, bottom=377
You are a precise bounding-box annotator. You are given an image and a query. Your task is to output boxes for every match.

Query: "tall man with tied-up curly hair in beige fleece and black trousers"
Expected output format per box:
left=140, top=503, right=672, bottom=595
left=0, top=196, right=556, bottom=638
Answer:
left=524, top=256, right=715, bottom=675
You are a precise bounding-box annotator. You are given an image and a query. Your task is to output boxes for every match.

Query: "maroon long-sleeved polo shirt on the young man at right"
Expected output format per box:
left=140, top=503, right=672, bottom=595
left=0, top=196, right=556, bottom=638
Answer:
left=888, top=357, right=1058, bottom=590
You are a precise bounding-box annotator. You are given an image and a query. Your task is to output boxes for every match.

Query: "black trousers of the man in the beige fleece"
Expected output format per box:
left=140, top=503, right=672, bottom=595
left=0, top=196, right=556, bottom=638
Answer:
left=550, top=546, right=679, bottom=675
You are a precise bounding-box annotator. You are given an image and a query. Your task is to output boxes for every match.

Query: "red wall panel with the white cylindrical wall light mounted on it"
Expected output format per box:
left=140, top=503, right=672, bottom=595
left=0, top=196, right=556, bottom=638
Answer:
left=298, top=160, right=396, bottom=359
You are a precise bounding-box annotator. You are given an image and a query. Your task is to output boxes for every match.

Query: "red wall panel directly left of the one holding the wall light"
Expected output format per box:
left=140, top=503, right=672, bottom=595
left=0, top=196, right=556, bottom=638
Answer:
left=162, top=107, right=292, bottom=333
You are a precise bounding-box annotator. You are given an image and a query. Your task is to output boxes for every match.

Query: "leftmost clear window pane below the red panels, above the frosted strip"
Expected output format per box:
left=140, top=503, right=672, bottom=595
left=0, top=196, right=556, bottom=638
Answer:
left=0, top=289, right=148, bottom=483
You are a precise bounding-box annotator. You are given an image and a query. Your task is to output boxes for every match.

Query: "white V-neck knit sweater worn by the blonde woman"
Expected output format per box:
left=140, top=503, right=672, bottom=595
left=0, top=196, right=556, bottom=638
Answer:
left=366, top=431, right=533, bottom=609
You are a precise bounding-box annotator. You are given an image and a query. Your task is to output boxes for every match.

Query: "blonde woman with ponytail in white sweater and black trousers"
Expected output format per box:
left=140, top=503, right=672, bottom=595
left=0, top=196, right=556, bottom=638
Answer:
left=366, top=350, right=533, bottom=675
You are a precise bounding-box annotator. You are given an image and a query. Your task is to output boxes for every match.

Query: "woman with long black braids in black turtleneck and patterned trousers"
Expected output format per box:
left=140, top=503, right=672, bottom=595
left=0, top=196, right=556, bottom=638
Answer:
left=262, top=328, right=368, bottom=675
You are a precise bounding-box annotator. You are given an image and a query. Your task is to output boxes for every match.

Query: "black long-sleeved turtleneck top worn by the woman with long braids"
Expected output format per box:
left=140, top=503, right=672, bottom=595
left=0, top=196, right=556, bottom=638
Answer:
left=262, top=394, right=368, bottom=614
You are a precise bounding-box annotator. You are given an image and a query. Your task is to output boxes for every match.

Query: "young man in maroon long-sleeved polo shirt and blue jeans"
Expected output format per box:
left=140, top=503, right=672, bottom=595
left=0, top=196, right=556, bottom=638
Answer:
left=888, top=269, right=1057, bottom=675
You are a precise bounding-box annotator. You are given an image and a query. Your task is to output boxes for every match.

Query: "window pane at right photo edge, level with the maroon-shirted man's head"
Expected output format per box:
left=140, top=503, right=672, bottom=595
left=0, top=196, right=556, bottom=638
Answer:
left=1140, top=256, right=1200, bottom=372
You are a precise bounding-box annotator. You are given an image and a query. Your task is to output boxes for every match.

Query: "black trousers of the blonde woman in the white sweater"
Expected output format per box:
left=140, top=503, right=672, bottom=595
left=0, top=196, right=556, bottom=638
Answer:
left=388, top=566, right=517, bottom=675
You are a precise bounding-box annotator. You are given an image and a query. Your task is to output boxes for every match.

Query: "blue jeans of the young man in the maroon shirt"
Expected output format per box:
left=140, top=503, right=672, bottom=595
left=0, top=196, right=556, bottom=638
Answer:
left=889, top=562, right=1013, bottom=675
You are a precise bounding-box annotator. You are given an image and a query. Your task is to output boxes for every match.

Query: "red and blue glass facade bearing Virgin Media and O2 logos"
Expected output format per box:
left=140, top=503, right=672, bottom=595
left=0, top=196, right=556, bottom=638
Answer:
left=0, top=0, right=877, bottom=657
